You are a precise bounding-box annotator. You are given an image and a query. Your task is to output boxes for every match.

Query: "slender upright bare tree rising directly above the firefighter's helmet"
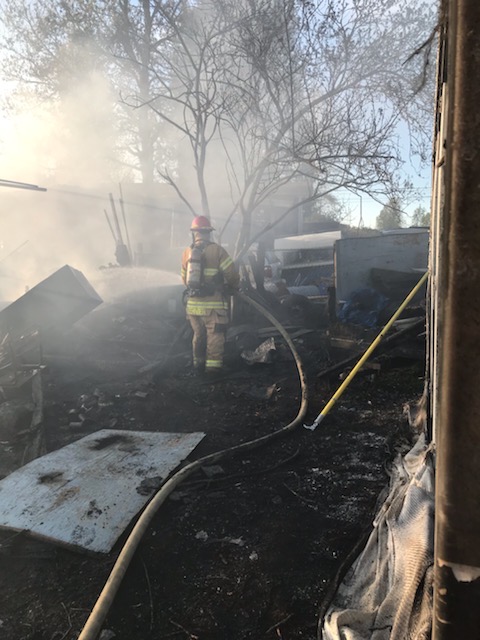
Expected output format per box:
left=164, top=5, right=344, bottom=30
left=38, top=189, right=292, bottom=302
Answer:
left=130, top=7, right=235, bottom=216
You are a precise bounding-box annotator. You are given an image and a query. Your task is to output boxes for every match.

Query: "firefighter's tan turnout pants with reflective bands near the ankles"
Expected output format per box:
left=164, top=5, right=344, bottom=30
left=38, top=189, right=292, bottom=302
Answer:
left=187, top=309, right=228, bottom=373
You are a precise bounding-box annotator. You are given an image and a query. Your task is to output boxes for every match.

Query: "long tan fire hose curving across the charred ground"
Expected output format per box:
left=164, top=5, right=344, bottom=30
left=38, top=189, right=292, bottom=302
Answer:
left=78, top=293, right=308, bottom=640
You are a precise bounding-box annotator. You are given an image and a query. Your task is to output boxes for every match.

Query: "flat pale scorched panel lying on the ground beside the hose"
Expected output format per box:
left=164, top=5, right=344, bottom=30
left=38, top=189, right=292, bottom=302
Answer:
left=0, top=429, right=204, bottom=553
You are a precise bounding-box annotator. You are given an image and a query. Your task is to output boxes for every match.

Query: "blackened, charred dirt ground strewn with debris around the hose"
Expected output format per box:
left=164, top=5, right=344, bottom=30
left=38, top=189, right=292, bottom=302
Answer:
left=0, top=270, right=424, bottom=640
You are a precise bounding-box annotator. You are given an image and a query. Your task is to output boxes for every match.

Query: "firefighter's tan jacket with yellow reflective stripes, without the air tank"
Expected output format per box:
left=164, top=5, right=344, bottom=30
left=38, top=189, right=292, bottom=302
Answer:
left=181, top=242, right=240, bottom=316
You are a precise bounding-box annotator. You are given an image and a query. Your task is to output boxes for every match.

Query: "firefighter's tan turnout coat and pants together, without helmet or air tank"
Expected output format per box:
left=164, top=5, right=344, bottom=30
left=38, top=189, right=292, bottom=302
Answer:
left=181, top=242, right=240, bottom=372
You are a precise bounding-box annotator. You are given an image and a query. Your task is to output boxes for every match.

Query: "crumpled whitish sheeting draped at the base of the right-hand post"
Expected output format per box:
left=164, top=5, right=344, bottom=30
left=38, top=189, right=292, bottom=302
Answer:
left=319, top=435, right=434, bottom=640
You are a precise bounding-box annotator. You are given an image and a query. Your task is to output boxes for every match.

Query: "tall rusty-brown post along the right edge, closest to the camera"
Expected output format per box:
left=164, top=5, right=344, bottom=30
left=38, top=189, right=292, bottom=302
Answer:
left=433, top=0, right=480, bottom=640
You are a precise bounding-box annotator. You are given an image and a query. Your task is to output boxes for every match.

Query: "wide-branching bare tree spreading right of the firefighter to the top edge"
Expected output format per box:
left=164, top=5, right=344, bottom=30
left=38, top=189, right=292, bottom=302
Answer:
left=146, top=0, right=434, bottom=253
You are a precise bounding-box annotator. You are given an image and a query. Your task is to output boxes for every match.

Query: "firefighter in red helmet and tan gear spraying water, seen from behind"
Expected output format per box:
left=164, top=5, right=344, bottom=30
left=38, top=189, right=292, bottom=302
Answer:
left=181, top=216, right=240, bottom=375
